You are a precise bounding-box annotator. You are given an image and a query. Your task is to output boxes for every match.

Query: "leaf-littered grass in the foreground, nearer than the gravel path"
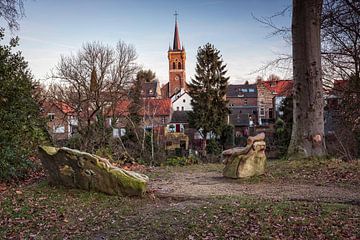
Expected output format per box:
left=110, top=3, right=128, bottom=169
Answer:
left=0, top=182, right=360, bottom=239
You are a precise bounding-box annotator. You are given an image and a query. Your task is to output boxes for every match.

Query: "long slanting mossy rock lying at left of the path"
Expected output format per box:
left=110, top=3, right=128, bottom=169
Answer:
left=39, top=146, right=149, bottom=196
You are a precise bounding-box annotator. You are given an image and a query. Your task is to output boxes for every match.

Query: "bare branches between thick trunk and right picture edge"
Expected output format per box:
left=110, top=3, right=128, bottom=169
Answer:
left=322, top=0, right=360, bottom=85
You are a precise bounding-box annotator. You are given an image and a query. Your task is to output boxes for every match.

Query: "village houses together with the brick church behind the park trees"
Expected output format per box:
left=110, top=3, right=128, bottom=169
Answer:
left=43, top=16, right=292, bottom=153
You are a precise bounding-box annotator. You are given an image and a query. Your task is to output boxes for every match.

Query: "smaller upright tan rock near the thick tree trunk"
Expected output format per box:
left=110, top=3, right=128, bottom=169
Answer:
left=222, top=133, right=266, bottom=178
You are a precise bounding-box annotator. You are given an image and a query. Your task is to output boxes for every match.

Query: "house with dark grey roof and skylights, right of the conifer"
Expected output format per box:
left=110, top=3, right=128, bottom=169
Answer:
left=226, top=82, right=257, bottom=136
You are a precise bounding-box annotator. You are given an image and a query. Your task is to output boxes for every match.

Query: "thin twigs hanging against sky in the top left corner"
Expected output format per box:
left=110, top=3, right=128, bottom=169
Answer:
left=0, top=0, right=24, bottom=30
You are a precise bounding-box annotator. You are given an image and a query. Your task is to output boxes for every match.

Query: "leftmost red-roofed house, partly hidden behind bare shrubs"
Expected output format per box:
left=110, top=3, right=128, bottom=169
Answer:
left=42, top=101, right=78, bottom=141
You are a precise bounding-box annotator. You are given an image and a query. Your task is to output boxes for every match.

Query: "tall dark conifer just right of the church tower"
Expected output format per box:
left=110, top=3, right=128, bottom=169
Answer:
left=189, top=43, right=230, bottom=154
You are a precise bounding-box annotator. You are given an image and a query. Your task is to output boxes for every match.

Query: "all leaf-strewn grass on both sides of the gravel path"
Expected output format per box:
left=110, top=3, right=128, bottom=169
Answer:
left=0, top=160, right=360, bottom=239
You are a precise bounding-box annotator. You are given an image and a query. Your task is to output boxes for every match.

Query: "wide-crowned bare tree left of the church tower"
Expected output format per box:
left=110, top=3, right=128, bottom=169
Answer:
left=52, top=41, right=138, bottom=150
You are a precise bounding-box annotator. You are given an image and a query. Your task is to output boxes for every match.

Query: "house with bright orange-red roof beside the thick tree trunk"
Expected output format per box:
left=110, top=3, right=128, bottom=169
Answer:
left=257, top=79, right=292, bottom=125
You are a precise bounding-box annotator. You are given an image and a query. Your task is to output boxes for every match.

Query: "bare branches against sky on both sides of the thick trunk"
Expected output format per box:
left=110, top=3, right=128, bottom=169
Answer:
left=254, top=0, right=360, bottom=88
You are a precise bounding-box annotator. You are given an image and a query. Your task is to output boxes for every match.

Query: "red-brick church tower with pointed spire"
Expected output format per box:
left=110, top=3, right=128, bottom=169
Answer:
left=168, top=13, right=186, bottom=97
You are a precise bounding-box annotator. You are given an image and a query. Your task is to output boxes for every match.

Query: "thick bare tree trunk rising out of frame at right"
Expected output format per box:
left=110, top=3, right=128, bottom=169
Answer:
left=288, top=0, right=326, bottom=158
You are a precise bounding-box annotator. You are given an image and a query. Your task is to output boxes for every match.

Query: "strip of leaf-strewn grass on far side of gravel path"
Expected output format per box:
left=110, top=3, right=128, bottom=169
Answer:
left=147, top=159, right=360, bottom=187
